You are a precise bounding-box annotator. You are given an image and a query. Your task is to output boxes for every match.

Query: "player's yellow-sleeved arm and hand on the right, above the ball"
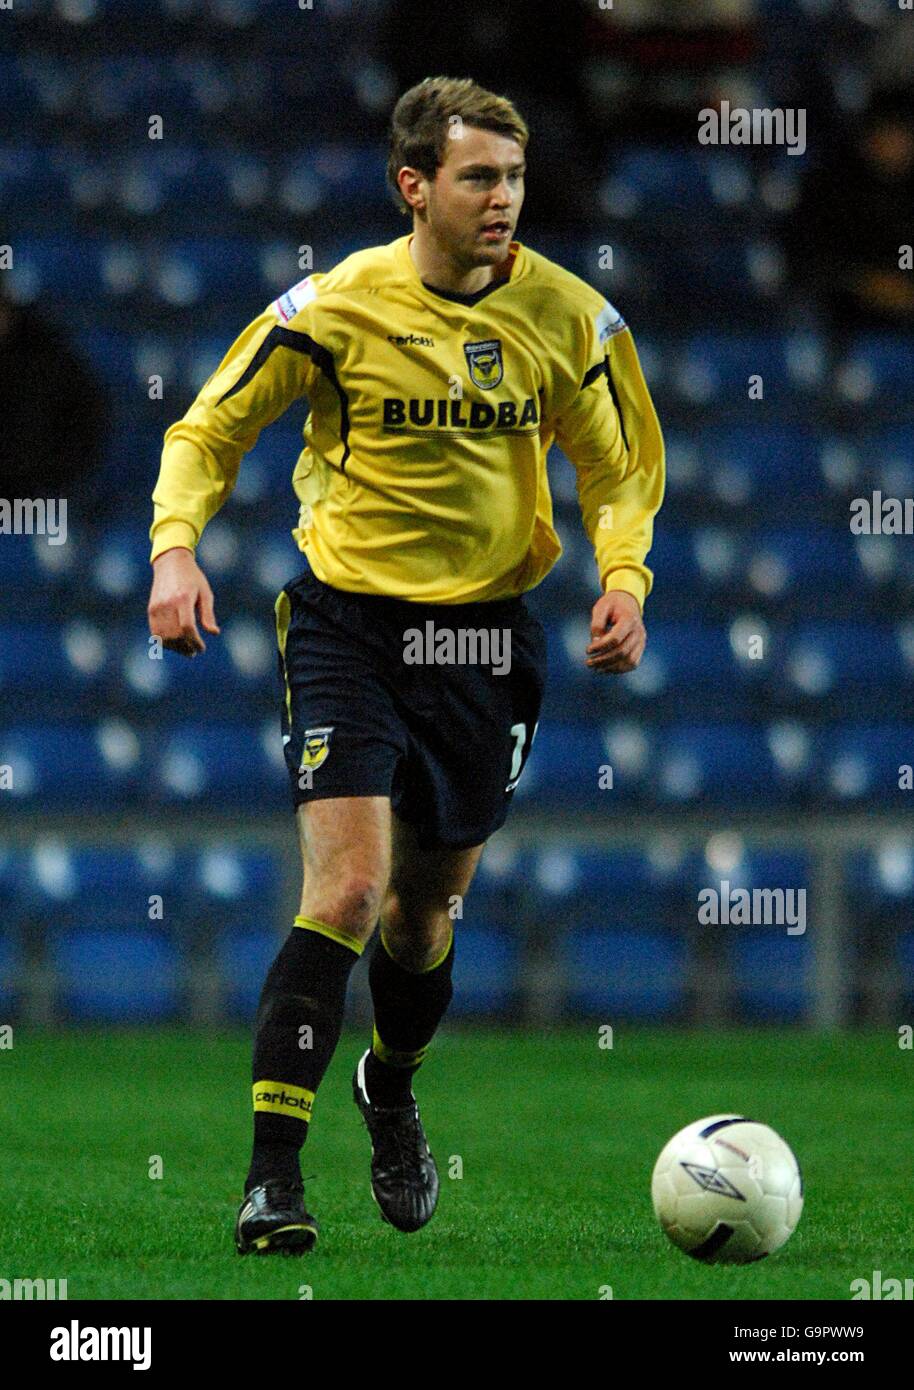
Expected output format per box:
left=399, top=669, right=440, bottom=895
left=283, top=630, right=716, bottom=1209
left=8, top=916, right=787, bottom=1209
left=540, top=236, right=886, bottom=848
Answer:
left=556, top=303, right=664, bottom=674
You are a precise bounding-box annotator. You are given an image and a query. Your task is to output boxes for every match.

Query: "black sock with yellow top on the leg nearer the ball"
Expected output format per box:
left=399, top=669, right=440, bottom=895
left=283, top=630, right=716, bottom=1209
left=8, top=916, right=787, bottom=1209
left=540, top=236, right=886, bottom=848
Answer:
left=365, top=930, right=454, bottom=1105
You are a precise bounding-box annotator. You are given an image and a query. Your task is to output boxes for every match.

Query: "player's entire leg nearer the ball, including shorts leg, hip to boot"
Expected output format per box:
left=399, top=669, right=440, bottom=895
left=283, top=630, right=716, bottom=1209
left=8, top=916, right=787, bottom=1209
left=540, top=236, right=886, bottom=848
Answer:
left=353, top=600, right=546, bottom=1230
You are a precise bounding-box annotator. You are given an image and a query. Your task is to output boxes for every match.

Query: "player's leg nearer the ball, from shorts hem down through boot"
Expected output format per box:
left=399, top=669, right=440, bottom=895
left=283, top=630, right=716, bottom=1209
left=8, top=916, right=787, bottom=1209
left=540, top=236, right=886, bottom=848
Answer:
left=353, top=816, right=483, bottom=1232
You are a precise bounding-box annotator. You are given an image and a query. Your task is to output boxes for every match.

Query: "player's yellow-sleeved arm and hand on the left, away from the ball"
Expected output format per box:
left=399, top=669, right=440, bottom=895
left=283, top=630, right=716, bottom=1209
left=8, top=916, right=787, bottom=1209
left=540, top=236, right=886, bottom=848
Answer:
left=147, top=278, right=319, bottom=656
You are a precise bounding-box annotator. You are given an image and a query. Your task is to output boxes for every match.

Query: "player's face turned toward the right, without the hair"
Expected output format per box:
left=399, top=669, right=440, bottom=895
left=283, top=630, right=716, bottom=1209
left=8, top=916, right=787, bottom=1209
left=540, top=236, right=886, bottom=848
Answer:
left=426, top=125, right=524, bottom=267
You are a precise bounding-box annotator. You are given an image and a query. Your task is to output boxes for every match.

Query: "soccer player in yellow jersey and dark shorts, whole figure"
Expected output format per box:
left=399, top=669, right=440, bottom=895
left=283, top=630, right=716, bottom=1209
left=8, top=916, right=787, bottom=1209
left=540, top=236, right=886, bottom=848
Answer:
left=149, top=78, right=664, bottom=1254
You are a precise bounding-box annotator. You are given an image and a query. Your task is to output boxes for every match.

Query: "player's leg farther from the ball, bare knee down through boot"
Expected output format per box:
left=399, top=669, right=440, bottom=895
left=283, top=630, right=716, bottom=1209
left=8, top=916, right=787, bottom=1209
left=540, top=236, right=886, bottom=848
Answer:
left=236, top=796, right=390, bottom=1254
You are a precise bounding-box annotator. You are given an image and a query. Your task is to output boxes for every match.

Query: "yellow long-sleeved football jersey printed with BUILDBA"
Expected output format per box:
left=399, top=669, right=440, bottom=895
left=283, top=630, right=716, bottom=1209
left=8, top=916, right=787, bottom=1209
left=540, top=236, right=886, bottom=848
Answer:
left=150, top=235, right=664, bottom=605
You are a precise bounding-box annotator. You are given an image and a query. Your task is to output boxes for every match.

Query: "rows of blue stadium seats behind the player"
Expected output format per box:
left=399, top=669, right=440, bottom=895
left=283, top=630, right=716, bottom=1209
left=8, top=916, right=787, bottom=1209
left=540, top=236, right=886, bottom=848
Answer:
left=0, top=0, right=914, bottom=1020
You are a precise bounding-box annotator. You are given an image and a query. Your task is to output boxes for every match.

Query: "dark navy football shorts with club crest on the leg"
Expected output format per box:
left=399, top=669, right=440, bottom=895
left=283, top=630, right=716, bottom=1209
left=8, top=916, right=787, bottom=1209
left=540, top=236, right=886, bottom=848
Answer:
left=276, top=570, right=546, bottom=849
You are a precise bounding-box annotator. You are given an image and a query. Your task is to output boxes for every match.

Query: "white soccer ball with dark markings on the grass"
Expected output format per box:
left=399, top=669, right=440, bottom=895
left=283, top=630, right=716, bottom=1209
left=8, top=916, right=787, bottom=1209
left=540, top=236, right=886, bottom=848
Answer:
left=650, top=1115, right=803, bottom=1265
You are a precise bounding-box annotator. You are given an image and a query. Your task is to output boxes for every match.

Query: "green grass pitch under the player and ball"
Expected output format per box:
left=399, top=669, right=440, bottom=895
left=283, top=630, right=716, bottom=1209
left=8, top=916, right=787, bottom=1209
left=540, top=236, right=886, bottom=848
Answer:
left=0, top=1024, right=914, bottom=1300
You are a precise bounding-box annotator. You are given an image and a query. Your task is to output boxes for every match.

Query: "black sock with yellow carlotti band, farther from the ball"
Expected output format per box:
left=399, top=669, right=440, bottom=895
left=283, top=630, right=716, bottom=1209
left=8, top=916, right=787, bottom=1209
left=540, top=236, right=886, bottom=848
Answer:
left=244, top=917, right=363, bottom=1193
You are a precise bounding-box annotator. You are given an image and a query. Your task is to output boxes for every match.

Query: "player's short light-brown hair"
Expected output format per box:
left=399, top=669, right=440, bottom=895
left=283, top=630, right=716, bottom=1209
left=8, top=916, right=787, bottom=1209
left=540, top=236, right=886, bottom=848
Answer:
left=388, top=78, right=529, bottom=213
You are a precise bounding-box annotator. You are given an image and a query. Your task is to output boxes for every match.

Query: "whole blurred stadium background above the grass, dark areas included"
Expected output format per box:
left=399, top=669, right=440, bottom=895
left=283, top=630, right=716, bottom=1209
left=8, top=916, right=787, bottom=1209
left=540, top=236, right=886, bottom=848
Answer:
left=0, top=0, right=914, bottom=1026
